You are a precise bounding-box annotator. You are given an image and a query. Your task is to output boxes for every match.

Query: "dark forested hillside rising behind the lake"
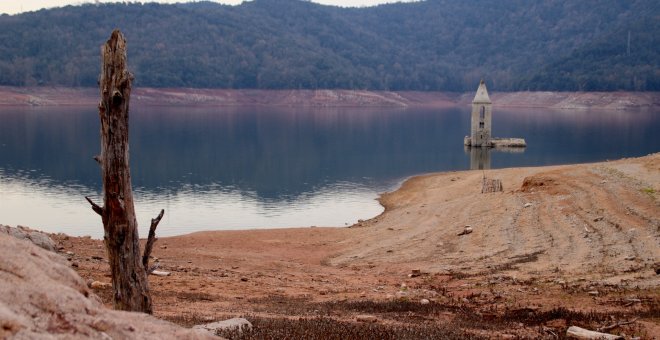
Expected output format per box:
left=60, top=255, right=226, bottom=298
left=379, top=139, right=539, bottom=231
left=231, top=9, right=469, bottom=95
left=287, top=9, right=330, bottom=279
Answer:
left=0, top=0, right=660, bottom=91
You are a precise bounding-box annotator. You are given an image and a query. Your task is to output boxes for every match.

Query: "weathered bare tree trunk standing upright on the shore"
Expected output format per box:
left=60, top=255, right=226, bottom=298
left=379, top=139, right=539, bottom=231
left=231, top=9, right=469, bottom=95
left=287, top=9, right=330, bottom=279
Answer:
left=87, top=30, right=163, bottom=313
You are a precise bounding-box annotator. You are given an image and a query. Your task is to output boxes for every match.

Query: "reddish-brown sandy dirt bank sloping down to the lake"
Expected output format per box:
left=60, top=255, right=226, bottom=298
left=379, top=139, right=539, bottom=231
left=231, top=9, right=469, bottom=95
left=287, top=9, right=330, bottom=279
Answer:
left=47, top=153, right=660, bottom=339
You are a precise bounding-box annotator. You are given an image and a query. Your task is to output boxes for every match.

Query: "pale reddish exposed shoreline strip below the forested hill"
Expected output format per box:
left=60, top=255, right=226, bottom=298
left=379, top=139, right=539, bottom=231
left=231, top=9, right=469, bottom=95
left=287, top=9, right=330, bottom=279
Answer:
left=0, top=86, right=660, bottom=110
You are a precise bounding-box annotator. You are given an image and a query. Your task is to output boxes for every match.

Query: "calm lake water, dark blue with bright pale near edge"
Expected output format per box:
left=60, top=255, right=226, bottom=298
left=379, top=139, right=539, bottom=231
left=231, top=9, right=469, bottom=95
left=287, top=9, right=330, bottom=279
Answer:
left=0, top=107, right=660, bottom=238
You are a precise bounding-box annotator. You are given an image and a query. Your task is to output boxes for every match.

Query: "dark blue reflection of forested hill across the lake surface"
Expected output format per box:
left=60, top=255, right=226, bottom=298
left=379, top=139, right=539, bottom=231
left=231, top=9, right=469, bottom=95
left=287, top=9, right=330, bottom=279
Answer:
left=0, top=107, right=660, bottom=201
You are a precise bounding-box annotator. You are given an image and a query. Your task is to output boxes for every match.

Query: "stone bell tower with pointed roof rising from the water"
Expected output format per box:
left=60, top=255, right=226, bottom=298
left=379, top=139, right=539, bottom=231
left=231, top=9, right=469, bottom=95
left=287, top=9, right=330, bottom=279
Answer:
left=465, top=79, right=493, bottom=147
